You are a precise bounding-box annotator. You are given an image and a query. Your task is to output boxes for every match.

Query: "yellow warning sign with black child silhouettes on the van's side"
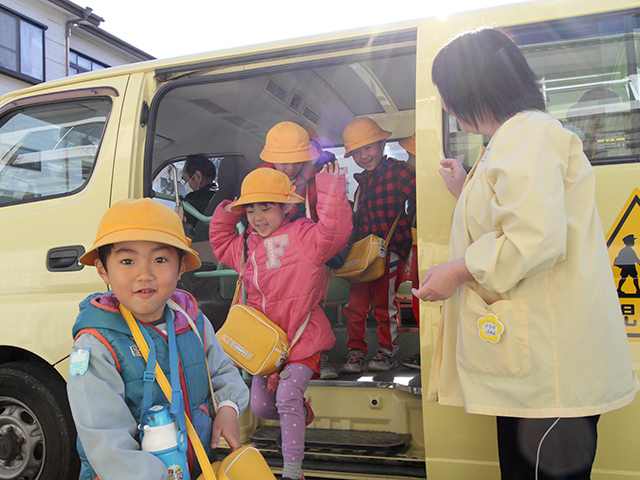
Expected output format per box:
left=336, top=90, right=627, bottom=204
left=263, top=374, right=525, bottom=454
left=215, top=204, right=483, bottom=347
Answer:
left=607, top=188, right=640, bottom=342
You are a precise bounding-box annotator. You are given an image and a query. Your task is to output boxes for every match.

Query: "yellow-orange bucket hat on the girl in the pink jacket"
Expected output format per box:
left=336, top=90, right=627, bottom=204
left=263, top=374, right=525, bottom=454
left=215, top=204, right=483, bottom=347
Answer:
left=231, top=168, right=304, bottom=212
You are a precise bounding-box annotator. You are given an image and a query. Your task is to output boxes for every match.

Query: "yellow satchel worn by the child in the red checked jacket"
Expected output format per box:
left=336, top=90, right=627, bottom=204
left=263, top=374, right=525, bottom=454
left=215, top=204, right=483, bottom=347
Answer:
left=332, top=211, right=402, bottom=283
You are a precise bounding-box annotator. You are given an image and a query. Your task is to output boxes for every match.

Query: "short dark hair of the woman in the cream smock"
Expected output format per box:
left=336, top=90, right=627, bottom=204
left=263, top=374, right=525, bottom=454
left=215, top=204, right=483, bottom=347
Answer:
left=431, top=28, right=546, bottom=127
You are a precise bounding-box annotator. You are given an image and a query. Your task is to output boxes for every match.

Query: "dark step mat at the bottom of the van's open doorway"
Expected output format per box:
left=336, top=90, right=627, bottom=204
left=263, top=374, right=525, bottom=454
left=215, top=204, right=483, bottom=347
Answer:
left=250, top=426, right=411, bottom=456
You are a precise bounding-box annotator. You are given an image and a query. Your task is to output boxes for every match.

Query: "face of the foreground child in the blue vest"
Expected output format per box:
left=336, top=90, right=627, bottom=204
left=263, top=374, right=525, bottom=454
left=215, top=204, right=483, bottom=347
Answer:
left=95, top=241, right=185, bottom=323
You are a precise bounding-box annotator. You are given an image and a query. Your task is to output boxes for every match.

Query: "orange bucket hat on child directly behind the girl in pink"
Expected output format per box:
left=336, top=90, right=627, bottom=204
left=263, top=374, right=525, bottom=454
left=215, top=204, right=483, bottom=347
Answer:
left=260, top=122, right=319, bottom=163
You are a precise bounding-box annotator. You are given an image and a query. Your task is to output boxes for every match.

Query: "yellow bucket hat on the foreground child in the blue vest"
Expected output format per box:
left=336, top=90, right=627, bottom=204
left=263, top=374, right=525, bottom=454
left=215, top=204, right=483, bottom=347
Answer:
left=80, top=198, right=201, bottom=271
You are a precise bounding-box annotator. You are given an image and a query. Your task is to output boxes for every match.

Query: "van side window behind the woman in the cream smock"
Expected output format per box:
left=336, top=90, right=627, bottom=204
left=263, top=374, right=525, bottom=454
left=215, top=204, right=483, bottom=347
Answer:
left=444, top=18, right=640, bottom=165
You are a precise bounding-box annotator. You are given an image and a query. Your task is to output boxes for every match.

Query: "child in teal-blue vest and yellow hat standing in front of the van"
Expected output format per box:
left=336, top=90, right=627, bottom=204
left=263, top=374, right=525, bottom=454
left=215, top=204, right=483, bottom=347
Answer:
left=67, top=198, right=249, bottom=480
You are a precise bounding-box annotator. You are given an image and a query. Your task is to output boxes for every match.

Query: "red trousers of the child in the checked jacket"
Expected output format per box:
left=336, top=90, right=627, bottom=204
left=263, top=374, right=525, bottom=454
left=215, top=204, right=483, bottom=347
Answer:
left=342, top=252, right=403, bottom=355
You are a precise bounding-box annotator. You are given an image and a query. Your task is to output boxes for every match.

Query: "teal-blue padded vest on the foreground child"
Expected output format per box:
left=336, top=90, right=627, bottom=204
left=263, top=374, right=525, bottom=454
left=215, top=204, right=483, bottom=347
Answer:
left=73, top=293, right=215, bottom=480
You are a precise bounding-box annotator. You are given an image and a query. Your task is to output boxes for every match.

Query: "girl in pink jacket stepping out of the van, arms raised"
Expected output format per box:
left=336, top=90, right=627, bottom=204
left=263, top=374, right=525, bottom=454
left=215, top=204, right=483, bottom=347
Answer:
left=209, top=163, right=352, bottom=480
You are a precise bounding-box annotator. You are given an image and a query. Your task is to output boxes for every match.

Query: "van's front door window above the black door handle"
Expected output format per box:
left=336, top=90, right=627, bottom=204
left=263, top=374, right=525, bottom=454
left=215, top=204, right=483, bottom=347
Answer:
left=0, top=98, right=111, bottom=206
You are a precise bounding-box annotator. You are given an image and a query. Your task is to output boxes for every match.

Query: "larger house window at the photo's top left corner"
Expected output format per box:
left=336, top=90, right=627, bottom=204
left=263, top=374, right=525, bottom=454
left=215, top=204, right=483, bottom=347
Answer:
left=0, top=7, right=47, bottom=83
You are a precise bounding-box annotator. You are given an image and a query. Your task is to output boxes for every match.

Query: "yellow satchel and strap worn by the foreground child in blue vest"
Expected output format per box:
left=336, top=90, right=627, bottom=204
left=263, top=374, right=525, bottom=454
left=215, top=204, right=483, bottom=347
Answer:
left=120, top=300, right=276, bottom=480
